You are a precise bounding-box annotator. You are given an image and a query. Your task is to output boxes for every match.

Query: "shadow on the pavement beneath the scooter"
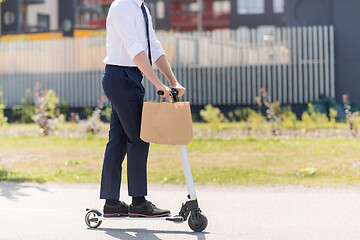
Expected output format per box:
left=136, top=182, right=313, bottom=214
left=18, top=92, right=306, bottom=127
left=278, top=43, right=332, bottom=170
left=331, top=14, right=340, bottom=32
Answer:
left=91, top=228, right=209, bottom=240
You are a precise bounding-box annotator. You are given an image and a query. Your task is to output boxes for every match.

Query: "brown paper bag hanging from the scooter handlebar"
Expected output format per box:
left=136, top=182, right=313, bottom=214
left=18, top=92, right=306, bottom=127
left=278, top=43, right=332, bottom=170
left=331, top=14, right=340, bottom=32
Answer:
left=140, top=102, right=193, bottom=145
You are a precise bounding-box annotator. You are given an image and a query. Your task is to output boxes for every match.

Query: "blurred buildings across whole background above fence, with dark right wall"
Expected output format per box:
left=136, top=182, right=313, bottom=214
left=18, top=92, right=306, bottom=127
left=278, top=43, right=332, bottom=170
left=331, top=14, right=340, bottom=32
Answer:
left=1, top=0, right=360, bottom=106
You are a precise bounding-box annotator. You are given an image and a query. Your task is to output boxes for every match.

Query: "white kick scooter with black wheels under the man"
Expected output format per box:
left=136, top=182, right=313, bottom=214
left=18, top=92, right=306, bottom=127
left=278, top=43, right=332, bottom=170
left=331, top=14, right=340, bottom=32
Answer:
left=85, top=88, right=208, bottom=232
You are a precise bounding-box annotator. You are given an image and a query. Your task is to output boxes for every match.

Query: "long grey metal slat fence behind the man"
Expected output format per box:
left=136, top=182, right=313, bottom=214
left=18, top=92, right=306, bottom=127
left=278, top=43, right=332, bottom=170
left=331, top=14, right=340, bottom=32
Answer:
left=0, top=26, right=335, bottom=107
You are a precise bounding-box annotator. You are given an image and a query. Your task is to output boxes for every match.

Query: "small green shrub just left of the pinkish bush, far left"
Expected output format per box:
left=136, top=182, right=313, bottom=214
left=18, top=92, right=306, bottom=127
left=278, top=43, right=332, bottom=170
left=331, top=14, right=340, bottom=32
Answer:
left=12, top=89, right=35, bottom=123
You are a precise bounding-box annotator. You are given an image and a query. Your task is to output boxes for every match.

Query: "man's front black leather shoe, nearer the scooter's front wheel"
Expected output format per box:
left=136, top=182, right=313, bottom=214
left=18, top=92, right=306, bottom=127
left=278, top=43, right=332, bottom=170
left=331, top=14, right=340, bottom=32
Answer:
left=129, top=201, right=170, bottom=217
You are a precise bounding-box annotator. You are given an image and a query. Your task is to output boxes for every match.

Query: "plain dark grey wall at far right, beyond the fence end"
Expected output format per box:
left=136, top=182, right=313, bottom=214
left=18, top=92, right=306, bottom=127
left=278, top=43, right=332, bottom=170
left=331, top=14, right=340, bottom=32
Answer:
left=286, top=0, right=360, bottom=104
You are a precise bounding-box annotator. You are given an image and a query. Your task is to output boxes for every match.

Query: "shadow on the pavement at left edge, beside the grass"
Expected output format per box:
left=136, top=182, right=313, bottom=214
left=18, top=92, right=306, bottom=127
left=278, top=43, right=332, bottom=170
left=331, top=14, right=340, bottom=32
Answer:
left=0, top=181, right=48, bottom=201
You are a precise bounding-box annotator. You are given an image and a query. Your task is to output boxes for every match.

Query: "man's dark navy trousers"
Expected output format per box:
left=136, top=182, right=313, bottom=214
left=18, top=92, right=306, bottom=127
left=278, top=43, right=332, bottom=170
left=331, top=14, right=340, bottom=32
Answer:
left=100, top=65, right=149, bottom=199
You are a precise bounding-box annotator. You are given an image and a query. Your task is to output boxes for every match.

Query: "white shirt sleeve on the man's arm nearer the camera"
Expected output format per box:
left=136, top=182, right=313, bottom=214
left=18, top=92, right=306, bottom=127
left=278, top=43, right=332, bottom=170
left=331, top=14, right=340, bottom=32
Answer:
left=108, top=3, right=145, bottom=60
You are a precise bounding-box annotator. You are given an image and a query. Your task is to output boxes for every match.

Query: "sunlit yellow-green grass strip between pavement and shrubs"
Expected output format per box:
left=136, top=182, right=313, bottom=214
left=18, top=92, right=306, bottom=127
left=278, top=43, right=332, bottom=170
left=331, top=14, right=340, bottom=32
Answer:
left=0, top=136, right=360, bottom=185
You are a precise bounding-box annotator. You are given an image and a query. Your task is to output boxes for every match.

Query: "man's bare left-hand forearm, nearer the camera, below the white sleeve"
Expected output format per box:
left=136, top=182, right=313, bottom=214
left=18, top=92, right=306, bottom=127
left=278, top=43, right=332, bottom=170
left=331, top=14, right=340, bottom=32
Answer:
left=133, top=51, right=171, bottom=97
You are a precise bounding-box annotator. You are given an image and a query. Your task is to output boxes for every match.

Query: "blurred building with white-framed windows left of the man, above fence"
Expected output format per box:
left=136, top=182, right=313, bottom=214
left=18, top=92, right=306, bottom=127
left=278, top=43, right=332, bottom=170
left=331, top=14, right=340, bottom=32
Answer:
left=1, top=0, right=103, bottom=38
